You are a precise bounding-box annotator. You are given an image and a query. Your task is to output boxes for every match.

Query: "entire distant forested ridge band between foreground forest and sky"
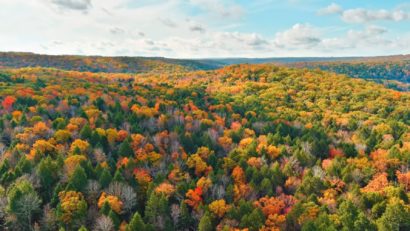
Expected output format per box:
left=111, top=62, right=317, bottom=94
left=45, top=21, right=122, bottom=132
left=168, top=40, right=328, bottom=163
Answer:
left=0, top=52, right=410, bottom=91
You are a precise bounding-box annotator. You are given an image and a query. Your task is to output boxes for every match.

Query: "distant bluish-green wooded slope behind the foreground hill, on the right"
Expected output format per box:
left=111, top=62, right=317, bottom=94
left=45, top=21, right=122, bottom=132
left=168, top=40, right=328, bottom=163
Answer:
left=205, top=55, right=410, bottom=91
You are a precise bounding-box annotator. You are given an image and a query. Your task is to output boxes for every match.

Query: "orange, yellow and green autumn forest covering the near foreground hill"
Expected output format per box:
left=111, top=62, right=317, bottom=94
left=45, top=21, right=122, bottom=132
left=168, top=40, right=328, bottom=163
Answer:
left=0, top=65, right=410, bottom=231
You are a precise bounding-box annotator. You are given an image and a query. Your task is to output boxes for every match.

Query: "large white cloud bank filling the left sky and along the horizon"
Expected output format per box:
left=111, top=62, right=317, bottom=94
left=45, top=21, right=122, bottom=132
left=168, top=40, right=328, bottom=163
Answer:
left=0, top=0, right=410, bottom=58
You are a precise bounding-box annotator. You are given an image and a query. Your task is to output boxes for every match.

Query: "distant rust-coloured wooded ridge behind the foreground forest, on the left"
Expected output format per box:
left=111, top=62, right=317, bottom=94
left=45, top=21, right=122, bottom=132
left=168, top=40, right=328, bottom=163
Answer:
left=0, top=52, right=215, bottom=73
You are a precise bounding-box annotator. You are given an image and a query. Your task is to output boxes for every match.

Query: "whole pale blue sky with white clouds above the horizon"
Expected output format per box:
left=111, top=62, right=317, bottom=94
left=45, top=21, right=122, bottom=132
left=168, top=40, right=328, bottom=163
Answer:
left=0, top=0, right=410, bottom=58
